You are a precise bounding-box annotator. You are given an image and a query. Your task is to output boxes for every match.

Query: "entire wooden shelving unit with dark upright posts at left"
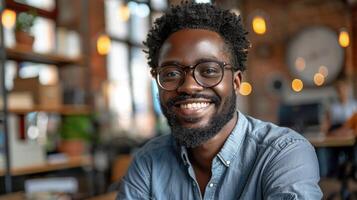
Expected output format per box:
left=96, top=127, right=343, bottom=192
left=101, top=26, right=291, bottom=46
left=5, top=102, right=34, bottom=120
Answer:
left=0, top=0, right=93, bottom=193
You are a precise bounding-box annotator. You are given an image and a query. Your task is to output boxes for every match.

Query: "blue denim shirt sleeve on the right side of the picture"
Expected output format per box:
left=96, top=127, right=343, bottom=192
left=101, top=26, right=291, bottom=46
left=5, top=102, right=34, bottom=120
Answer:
left=263, top=139, right=322, bottom=200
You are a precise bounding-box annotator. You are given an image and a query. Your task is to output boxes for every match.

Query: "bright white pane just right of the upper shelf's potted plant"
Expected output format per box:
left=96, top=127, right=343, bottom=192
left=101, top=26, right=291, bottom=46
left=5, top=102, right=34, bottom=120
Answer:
left=32, top=17, right=55, bottom=53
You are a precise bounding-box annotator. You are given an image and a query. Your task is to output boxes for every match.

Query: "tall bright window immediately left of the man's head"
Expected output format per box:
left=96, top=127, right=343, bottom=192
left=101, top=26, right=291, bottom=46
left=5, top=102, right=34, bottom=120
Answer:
left=105, top=0, right=168, bottom=137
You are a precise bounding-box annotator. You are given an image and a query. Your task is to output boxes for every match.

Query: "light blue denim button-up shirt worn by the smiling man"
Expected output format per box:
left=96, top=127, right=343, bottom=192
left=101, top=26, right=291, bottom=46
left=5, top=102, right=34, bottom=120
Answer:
left=117, top=112, right=322, bottom=200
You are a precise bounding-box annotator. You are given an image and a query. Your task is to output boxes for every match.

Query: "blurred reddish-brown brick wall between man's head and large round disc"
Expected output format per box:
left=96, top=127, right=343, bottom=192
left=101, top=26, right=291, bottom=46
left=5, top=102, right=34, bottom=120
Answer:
left=242, top=0, right=350, bottom=122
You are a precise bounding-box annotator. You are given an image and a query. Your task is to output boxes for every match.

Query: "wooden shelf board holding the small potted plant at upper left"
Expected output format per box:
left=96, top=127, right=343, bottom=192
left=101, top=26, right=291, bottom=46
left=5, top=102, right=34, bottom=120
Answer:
left=6, top=46, right=82, bottom=65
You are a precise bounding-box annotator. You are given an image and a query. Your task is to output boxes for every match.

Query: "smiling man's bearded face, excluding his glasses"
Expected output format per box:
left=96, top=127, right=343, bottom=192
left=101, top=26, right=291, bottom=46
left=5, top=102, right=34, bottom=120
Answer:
left=158, top=29, right=240, bottom=147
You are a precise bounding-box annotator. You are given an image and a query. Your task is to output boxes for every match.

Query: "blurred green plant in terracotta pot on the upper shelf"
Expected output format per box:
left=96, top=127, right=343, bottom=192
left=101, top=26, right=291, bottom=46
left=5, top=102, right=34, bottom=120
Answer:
left=15, top=11, right=36, bottom=51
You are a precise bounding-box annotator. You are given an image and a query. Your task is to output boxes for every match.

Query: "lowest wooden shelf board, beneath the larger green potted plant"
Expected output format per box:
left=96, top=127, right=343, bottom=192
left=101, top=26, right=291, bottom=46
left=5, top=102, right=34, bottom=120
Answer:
left=0, top=156, right=91, bottom=176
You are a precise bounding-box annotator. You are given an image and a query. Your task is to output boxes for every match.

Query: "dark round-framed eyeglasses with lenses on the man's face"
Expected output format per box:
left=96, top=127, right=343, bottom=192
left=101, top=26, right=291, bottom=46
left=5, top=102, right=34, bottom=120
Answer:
left=152, top=61, right=232, bottom=91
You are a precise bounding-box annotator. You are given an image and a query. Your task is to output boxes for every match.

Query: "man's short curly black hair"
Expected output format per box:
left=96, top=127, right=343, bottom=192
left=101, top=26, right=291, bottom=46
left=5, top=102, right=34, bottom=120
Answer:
left=144, top=2, right=250, bottom=71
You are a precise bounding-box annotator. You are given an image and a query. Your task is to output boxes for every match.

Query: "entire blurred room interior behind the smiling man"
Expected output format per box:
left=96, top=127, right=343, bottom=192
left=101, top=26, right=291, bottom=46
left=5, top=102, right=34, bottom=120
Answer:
left=0, top=0, right=357, bottom=199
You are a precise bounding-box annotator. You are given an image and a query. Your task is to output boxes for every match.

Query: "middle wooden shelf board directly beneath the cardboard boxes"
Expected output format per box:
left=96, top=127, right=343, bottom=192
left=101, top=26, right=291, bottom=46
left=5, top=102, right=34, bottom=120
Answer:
left=8, top=105, right=92, bottom=115
